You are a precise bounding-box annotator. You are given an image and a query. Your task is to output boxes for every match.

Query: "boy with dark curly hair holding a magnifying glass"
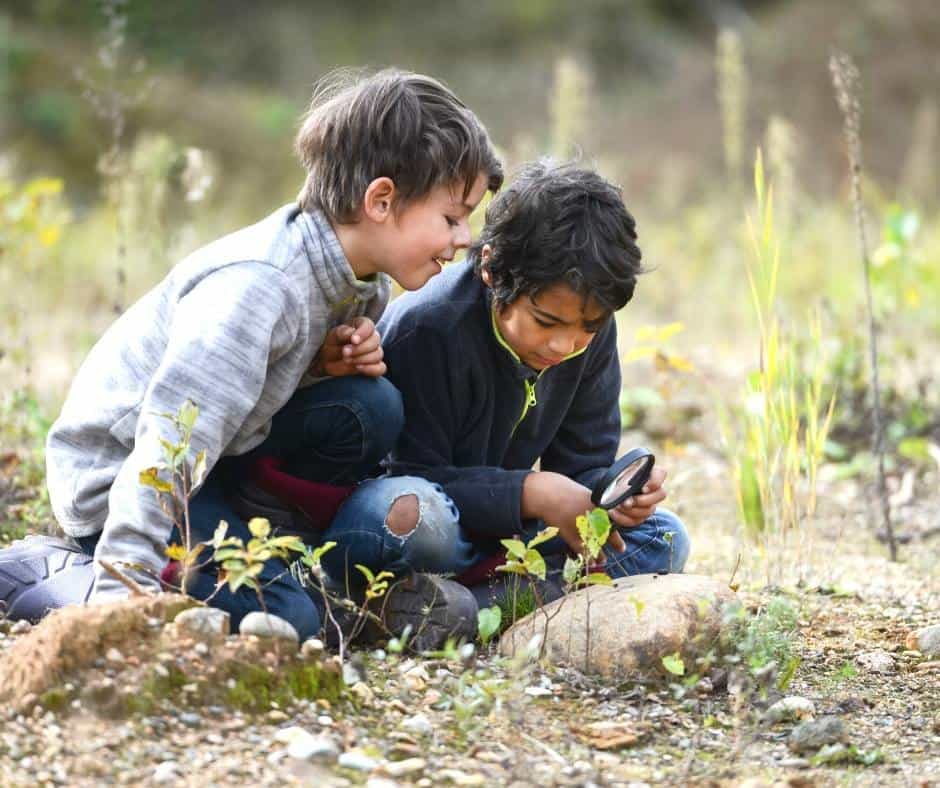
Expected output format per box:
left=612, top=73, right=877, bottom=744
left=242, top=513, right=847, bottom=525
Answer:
left=327, top=157, right=689, bottom=599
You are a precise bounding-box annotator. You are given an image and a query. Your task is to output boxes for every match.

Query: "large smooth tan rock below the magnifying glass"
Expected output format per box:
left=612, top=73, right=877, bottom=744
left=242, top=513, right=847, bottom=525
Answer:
left=499, top=574, right=735, bottom=678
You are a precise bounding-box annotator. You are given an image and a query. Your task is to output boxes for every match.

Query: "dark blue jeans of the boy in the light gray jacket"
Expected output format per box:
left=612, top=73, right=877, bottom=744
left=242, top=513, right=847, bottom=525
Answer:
left=80, top=376, right=404, bottom=640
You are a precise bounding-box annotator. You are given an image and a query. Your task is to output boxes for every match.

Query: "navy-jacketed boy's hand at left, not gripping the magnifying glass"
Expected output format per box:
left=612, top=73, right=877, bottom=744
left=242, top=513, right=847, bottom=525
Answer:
left=522, top=471, right=627, bottom=555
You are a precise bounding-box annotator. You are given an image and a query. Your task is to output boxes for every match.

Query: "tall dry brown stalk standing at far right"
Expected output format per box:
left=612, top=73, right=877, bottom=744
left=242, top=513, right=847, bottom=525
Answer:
left=829, top=52, right=898, bottom=561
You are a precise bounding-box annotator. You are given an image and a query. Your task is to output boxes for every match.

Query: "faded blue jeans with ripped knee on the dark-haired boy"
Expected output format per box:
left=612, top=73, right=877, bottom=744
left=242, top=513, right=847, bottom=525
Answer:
left=322, top=476, right=689, bottom=586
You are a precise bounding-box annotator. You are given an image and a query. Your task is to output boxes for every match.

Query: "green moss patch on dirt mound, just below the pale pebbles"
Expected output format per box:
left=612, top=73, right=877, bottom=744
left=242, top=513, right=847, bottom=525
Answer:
left=225, top=662, right=340, bottom=712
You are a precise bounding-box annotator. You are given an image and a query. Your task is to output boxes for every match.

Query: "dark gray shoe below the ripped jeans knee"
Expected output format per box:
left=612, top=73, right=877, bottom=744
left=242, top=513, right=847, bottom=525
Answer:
left=379, top=572, right=479, bottom=651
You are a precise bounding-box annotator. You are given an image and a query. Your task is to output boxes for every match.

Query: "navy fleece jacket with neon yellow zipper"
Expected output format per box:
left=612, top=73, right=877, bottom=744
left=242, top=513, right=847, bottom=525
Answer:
left=379, top=263, right=620, bottom=542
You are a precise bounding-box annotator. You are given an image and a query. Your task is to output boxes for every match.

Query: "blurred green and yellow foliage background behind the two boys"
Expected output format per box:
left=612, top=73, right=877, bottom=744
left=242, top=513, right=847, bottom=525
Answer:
left=0, top=0, right=940, bottom=552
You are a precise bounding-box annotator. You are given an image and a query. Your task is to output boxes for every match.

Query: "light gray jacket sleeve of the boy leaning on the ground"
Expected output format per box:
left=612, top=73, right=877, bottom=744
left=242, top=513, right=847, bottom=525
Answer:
left=93, top=263, right=299, bottom=599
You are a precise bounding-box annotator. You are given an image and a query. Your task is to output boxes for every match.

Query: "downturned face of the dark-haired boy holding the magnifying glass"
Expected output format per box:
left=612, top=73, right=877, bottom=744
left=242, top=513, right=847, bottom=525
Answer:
left=482, top=255, right=610, bottom=371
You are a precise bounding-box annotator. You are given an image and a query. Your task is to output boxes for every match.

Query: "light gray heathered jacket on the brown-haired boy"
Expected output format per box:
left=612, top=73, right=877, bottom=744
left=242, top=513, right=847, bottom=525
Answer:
left=46, top=205, right=390, bottom=598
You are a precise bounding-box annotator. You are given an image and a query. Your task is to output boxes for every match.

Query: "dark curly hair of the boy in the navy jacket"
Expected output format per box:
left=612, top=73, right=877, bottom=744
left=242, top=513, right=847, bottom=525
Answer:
left=467, top=159, right=645, bottom=312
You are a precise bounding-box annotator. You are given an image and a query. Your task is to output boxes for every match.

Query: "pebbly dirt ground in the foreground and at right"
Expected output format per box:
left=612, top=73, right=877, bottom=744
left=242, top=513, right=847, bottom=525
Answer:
left=0, top=446, right=940, bottom=788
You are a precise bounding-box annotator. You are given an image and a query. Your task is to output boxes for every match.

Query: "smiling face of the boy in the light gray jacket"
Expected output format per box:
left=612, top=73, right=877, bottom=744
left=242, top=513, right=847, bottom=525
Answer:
left=375, top=173, right=487, bottom=290
